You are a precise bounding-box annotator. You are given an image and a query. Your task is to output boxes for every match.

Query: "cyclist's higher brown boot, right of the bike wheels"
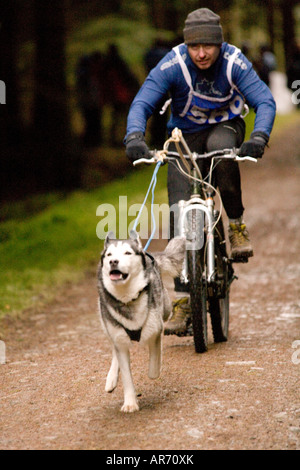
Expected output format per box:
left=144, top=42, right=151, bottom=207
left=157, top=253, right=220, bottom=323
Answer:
left=228, top=222, right=253, bottom=261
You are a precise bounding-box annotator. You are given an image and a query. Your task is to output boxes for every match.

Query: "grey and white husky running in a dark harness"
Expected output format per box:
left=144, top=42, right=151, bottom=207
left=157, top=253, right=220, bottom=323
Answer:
left=98, top=231, right=185, bottom=413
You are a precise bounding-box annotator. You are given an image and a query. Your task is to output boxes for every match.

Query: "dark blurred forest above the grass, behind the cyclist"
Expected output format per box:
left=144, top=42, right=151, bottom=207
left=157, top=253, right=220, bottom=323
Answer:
left=0, top=0, right=300, bottom=201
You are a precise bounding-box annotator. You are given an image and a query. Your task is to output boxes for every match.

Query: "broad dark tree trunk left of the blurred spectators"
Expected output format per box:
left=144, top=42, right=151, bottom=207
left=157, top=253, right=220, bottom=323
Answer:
left=32, top=0, right=80, bottom=190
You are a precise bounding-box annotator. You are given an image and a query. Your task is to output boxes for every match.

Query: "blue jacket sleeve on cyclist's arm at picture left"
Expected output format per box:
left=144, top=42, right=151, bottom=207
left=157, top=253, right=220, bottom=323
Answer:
left=125, top=52, right=174, bottom=139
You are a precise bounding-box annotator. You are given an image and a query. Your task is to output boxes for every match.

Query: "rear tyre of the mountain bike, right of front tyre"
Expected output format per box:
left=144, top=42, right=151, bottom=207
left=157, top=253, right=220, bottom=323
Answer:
left=208, top=219, right=233, bottom=343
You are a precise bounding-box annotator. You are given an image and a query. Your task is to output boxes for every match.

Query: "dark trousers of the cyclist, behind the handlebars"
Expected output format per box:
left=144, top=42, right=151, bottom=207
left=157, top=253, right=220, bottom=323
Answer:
left=168, top=118, right=245, bottom=292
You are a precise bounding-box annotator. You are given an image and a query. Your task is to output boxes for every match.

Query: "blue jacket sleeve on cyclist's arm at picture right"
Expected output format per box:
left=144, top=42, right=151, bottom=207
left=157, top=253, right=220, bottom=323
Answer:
left=232, top=54, right=276, bottom=136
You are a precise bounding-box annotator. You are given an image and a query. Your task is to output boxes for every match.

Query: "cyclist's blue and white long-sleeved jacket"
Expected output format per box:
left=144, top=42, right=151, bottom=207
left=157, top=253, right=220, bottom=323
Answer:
left=127, top=42, right=276, bottom=136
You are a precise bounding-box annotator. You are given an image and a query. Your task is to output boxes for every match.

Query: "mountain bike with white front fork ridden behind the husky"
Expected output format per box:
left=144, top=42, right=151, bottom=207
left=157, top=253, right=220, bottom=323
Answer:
left=134, top=128, right=257, bottom=353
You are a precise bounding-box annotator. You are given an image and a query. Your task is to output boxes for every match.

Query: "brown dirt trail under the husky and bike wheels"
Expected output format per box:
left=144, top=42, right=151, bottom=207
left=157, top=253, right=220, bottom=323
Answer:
left=0, top=119, right=300, bottom=450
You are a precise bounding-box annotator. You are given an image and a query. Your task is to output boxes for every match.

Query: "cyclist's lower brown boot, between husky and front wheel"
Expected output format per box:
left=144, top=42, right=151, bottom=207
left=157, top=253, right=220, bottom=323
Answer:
left=164, top=297, right=191, bottom=336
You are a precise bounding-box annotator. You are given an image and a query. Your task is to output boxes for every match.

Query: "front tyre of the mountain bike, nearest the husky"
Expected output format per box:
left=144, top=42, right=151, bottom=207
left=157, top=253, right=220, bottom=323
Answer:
left=187, top=209, right=207, bottom=353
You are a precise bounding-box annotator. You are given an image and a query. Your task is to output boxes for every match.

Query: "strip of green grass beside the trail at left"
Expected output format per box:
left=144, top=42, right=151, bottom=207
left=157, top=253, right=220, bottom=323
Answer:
left=0, top=167, right=166, bottom=318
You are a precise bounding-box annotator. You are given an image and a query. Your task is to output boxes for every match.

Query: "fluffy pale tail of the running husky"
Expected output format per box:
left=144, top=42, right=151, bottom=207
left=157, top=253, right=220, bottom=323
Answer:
left=155, top=238, right=185, bottom=278
